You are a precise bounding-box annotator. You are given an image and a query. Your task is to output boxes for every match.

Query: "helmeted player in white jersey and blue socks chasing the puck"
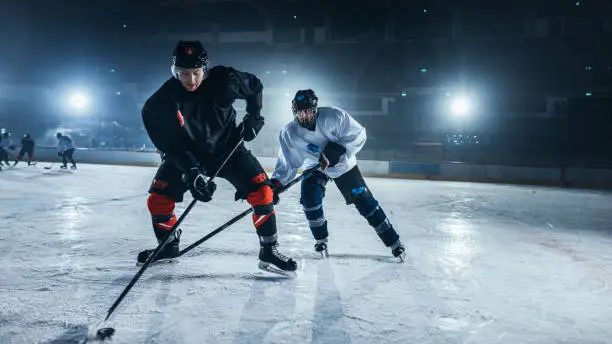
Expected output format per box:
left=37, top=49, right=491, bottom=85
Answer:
left=271, top=90, right=405, bottom=261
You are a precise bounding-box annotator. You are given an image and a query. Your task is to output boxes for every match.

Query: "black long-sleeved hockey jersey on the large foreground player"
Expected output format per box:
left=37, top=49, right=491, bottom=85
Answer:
left=142, top=66, right=263, bottom=170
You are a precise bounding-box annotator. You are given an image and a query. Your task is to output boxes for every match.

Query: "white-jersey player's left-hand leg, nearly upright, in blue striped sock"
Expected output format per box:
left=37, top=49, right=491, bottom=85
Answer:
left=300, top=171, right=329, bottom=255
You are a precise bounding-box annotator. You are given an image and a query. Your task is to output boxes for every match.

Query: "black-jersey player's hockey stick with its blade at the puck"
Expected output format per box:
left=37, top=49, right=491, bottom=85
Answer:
left=89, top=139, right=244, bottom=339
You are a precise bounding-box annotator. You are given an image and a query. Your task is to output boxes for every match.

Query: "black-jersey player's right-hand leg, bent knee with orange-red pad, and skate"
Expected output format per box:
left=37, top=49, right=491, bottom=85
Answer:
left=219, top=147, right=297, bottom=271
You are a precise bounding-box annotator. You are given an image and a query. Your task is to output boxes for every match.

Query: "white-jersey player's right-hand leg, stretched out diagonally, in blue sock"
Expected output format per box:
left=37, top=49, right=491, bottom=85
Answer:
left=334, top=166, right=404, bottom=257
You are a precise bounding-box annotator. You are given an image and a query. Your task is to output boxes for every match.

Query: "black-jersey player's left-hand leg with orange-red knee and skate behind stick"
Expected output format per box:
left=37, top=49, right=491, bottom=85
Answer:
left=138, top=160, right=186, bottom=263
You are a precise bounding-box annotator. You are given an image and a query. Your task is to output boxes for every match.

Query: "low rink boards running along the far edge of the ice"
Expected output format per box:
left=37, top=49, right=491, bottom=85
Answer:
left=29, top=147, right=612, bottom=188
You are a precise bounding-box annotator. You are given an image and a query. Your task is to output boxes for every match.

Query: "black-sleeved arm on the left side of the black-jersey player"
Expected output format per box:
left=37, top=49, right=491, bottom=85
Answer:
left=142, top=99, right=199, bottom=172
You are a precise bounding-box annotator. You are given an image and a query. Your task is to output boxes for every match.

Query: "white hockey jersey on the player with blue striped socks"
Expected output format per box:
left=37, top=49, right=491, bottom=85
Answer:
left=272, top=106, right=366, bottom=185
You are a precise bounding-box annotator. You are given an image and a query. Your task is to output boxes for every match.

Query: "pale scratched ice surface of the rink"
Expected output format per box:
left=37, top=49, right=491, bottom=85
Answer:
left=0, top=164, right=612, bottom=344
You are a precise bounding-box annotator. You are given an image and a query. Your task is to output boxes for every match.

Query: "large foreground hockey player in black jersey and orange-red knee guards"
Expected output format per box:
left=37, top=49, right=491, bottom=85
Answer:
left=138, top=41, right=297, bottom=271
